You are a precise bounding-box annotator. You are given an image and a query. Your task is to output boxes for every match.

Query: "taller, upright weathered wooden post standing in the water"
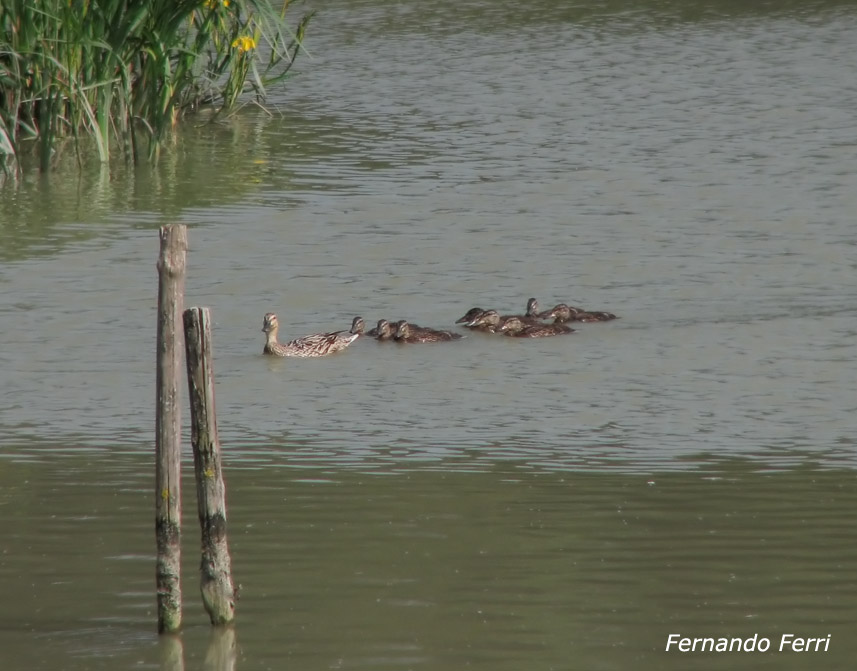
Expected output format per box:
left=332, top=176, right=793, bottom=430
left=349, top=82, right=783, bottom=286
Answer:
left=155, top=224, right=187, bottom=633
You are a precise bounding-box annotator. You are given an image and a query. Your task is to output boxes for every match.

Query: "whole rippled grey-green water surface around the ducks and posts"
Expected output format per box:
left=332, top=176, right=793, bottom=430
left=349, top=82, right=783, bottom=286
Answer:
left=0, top=0, right=857, bottom=669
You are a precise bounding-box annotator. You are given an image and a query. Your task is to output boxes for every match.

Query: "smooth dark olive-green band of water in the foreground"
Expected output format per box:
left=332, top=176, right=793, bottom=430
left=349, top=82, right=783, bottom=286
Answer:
left=0, top=454, right=857, bottom=669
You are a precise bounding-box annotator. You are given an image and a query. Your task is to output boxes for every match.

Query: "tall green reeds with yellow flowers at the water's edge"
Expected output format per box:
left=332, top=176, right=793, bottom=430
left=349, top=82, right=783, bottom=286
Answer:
left=0, top=0, right=312, bottom=170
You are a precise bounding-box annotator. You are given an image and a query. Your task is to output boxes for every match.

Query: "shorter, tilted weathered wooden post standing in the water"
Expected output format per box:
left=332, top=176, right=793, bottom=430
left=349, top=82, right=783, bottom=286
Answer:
left=184, top=308, right=235, bottom=624
